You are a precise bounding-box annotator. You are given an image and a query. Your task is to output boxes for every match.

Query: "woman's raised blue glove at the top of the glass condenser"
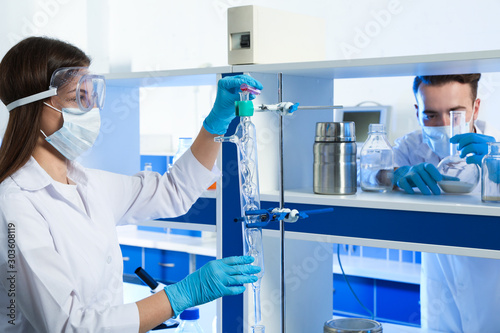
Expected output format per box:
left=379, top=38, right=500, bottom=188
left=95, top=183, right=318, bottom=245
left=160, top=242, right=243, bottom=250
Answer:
left=203, top=75, right=262, bottom=135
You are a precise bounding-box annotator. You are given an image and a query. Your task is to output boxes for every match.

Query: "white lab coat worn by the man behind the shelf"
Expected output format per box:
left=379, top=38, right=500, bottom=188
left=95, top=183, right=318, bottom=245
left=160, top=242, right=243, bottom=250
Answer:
left=394, top=121, right=500, bottom=333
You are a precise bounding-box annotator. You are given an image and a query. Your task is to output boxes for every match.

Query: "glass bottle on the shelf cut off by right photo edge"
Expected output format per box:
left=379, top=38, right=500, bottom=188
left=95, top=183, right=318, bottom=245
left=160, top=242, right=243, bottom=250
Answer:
left=481, top=142, right=500, bottom=203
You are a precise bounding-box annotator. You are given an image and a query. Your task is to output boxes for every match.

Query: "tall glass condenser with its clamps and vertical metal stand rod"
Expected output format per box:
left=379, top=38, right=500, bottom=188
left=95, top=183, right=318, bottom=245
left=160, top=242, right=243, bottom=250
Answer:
left=215, top=81, right=336, bottom=333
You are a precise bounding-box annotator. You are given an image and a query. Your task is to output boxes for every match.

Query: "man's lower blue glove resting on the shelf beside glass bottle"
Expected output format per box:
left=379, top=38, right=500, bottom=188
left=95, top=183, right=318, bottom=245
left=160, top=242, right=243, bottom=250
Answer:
left=393, top=163, right=448, bottom=195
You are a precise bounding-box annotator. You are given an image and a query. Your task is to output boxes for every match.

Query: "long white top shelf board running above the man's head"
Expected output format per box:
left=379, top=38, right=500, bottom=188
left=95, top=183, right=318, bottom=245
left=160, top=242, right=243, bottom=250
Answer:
left=104, top=50, right=500, bottom=86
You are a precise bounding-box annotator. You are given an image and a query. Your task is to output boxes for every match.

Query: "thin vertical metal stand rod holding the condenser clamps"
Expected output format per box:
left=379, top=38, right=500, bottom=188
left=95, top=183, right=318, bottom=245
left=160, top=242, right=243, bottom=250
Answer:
left=278, top=73, right=286, bottom=333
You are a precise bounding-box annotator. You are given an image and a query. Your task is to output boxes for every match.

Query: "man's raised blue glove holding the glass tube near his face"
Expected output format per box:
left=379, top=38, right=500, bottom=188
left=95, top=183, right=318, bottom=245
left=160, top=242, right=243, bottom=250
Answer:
left=450, top=133, right=496, bottom=166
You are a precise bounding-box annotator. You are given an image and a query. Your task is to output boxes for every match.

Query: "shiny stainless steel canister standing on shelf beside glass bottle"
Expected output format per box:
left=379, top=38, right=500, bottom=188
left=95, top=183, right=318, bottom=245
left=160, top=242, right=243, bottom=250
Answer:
left=313, top=121, right=357, bottom=194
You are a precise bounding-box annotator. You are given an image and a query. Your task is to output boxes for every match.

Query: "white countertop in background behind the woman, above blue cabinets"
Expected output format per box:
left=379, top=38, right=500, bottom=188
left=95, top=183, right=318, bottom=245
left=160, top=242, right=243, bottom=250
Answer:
left=118, top=229, right=217, bottom=257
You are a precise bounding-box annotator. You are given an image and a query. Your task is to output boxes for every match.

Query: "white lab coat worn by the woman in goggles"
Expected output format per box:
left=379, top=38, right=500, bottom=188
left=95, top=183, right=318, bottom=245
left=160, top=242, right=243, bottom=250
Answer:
left=0, top=150, right=220, bottom=333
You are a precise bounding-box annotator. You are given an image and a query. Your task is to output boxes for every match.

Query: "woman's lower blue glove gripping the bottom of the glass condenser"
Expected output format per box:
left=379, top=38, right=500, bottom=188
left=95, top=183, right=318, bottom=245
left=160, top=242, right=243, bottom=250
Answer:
left=165, top=256, right=260, bottom=317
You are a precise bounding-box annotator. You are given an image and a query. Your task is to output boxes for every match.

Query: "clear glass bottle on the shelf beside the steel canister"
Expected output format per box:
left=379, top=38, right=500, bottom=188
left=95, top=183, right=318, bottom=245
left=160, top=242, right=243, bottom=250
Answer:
left=359, top=124, right=394, bottom=192
